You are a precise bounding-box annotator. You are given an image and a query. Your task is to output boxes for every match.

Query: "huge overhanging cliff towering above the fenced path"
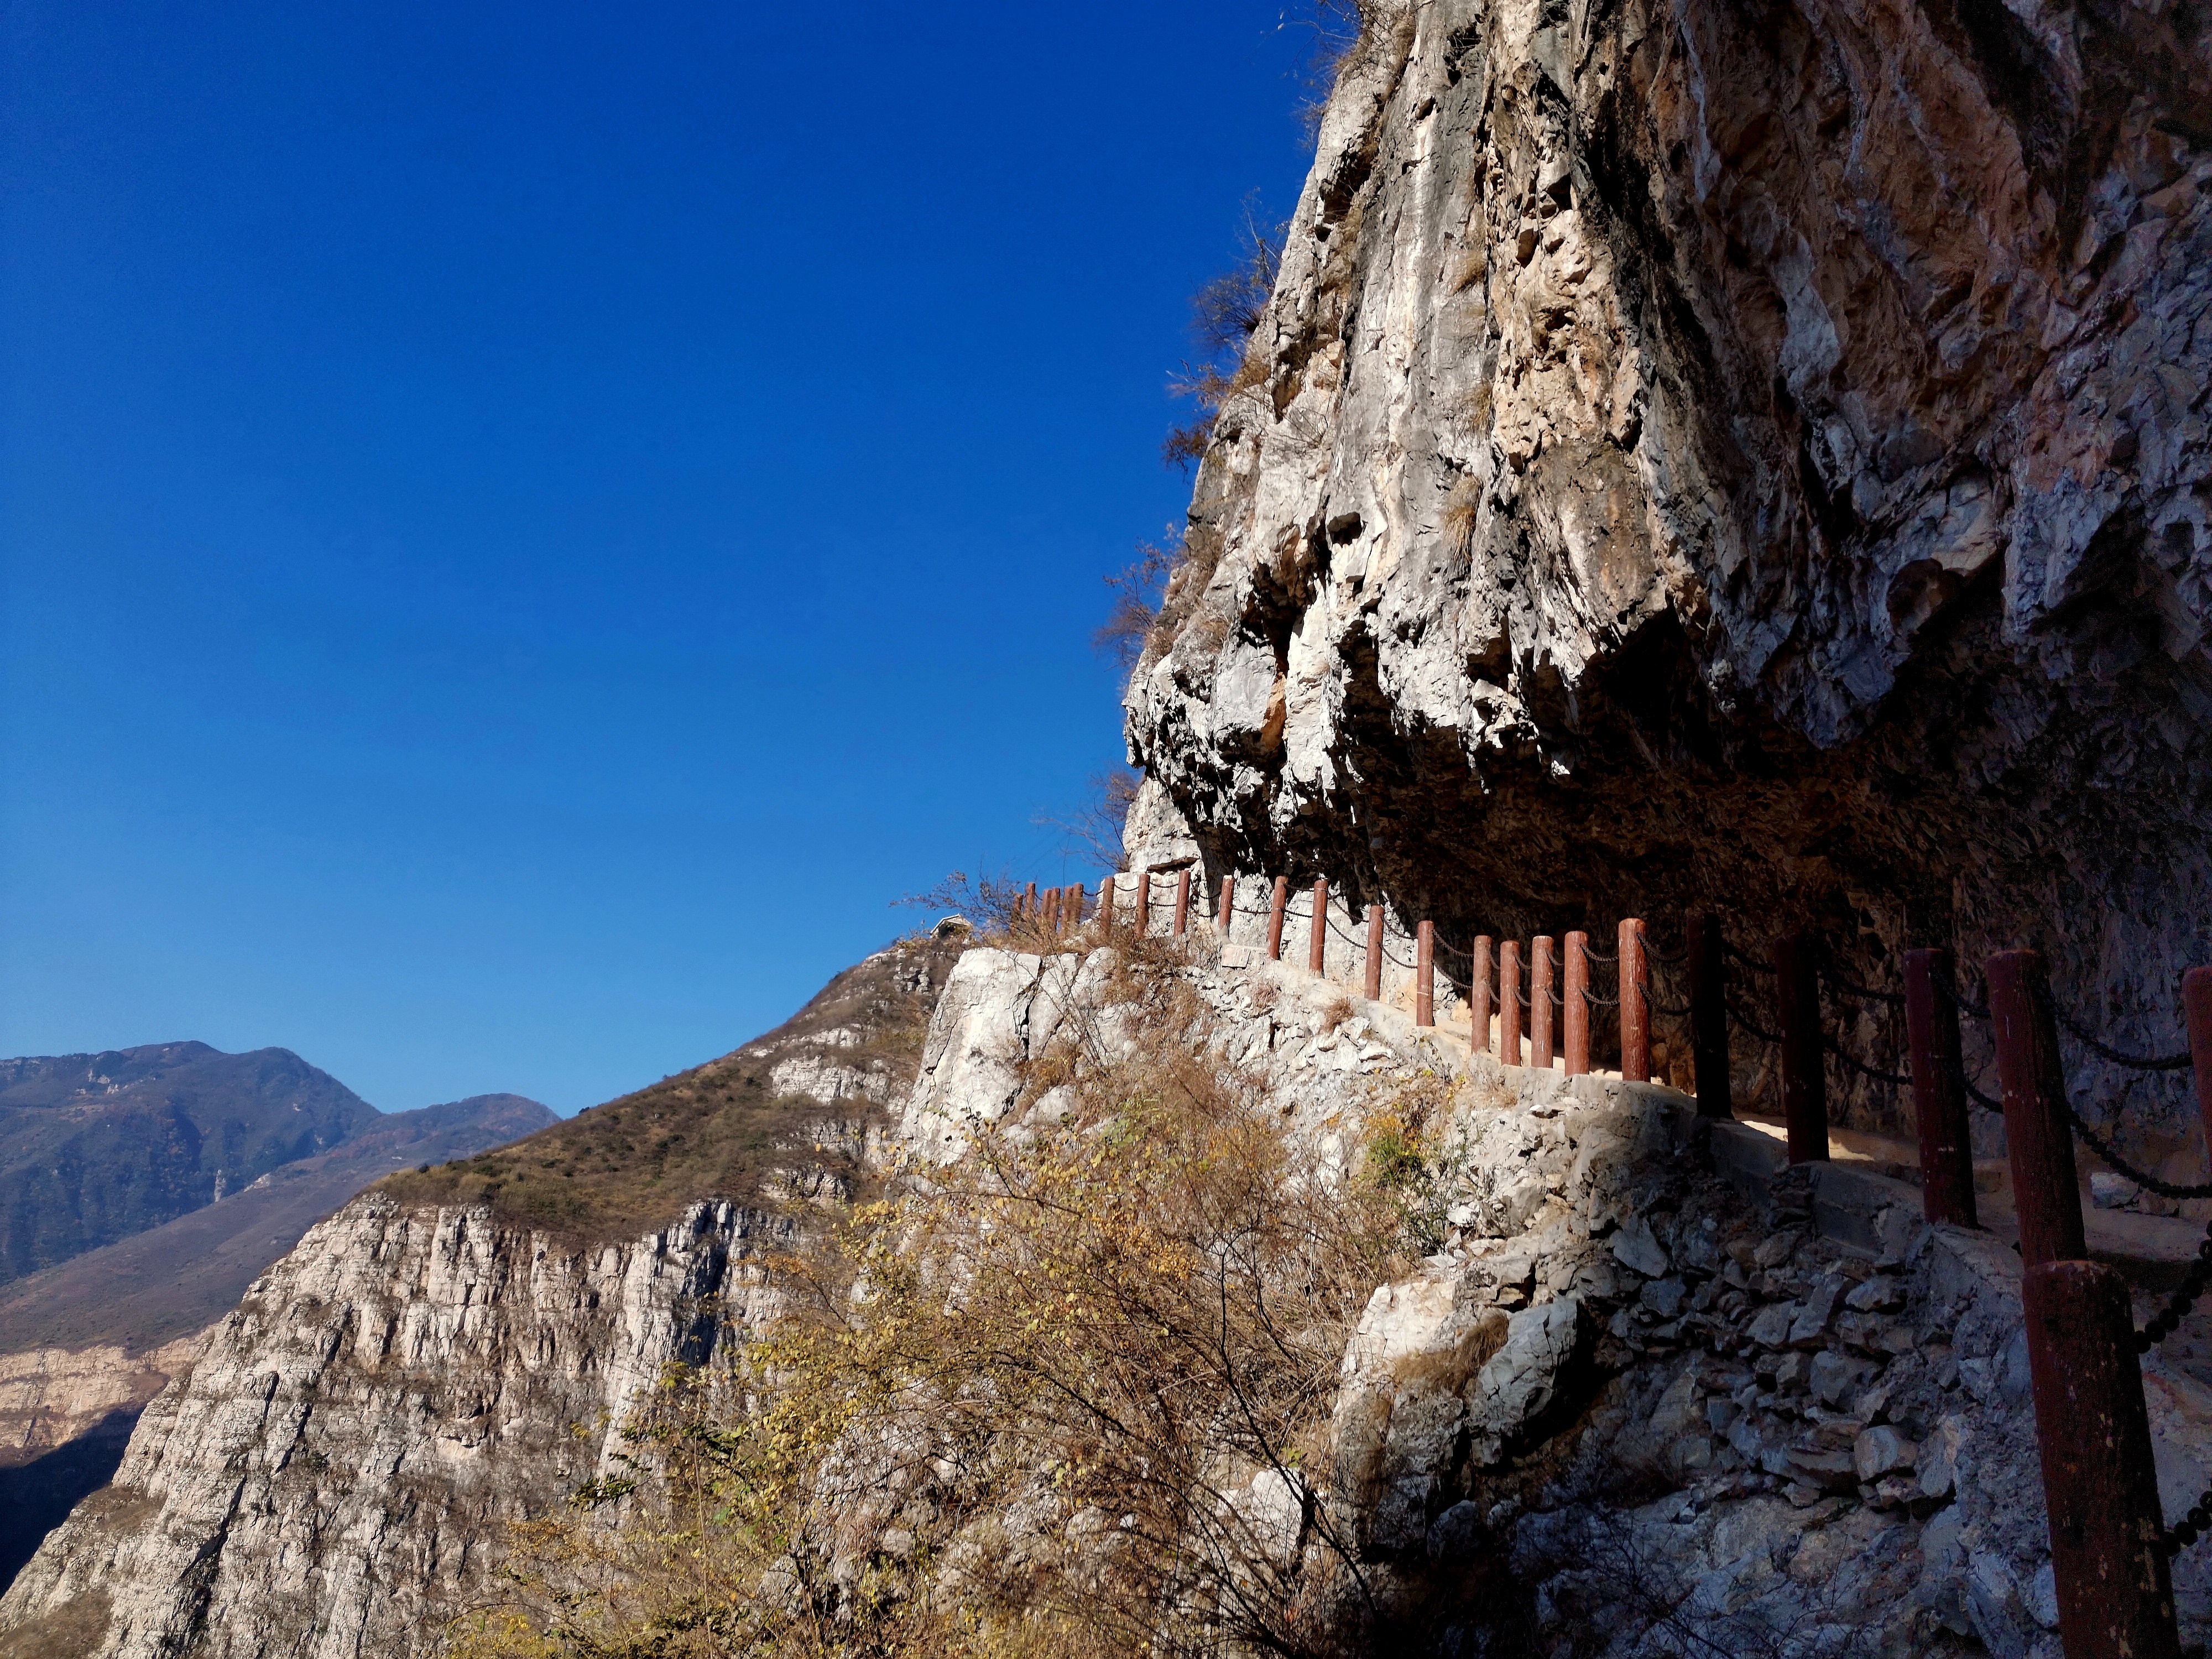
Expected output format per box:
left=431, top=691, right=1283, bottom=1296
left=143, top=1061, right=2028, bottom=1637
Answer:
left=1128, top=0, right=2212, bottom=1141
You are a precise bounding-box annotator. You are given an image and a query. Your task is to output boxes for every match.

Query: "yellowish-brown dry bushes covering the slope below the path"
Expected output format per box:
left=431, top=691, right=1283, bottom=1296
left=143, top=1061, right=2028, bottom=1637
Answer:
left=456, top=940, right=1409, bottom=1659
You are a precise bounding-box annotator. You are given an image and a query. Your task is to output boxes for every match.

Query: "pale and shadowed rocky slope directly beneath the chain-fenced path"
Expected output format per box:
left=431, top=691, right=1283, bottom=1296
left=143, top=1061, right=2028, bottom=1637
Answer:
left=872, top=947, right=2212, bottom=1659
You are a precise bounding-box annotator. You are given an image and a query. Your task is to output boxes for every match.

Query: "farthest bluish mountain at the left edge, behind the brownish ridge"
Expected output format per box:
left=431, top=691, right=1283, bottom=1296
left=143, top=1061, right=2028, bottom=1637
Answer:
left=0, top=1042, right=383, bottom=1285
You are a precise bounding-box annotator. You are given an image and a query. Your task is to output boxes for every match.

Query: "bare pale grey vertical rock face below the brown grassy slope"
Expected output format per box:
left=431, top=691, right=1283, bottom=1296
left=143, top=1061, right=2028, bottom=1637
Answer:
left=0, top=1194, right=790, bottom=1659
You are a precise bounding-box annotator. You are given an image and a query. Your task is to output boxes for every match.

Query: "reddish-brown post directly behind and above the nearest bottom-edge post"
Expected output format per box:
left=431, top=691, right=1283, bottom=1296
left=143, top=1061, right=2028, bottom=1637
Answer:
left=1989, top=951, right=2088, bottom=1267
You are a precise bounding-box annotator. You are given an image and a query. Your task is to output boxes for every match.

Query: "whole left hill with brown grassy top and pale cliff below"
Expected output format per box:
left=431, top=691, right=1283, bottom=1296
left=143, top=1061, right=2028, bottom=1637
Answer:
left=0, top=942, right=956, bottom=1659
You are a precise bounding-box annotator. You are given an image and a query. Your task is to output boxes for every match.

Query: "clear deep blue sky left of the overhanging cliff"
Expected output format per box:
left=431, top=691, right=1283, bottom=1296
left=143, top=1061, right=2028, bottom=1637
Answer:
left=0, top=0, right=1310, bottom=1113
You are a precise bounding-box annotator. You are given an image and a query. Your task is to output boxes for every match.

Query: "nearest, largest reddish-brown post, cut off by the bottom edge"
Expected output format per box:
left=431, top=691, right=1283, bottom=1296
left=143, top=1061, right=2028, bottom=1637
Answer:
left=2026, top=1256, right=2181, bottom=1659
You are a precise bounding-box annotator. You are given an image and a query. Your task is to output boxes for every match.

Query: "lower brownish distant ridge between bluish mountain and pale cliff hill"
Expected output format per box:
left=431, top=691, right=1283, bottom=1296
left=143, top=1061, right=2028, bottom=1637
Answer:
left=0, top=1095, right=560, bottom=1363
